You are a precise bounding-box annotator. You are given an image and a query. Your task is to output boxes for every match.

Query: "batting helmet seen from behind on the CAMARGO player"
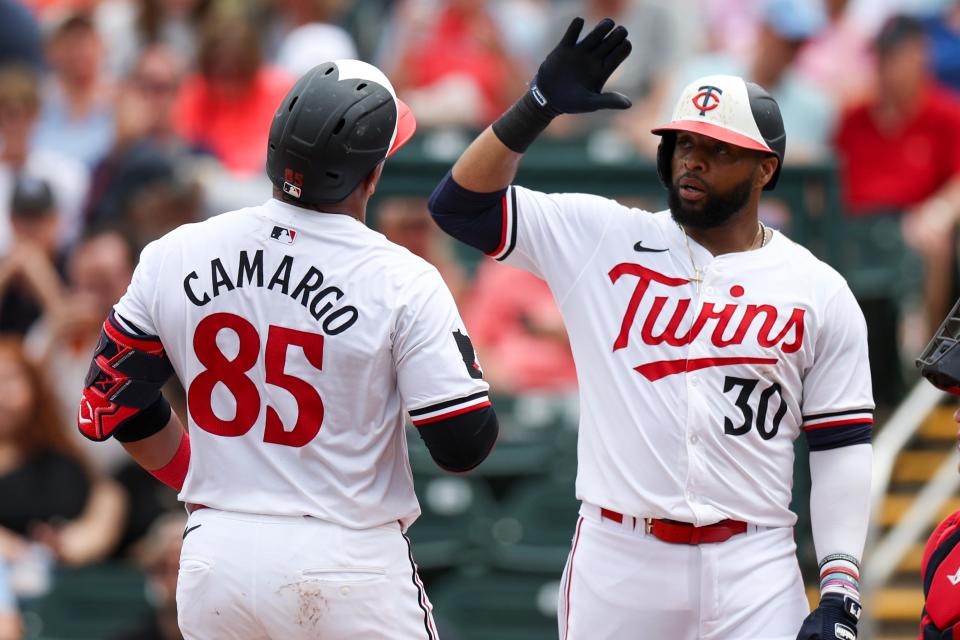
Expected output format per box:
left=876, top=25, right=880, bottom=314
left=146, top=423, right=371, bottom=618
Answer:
left=267, top=60, right=417, bottom=205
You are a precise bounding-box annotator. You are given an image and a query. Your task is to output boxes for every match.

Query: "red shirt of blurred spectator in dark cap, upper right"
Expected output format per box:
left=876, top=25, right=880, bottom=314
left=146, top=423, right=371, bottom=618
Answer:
left=836, top=84, right=960, bottom=215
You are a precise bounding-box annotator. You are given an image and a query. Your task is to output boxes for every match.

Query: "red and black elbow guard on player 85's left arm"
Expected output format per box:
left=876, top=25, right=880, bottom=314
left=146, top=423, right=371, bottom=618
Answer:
left=77, top=312, right=173, bottom=442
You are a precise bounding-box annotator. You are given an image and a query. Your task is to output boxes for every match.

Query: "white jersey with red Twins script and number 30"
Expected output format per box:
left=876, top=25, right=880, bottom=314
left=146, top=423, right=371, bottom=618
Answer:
left=489, top=187, right=873, bottom=526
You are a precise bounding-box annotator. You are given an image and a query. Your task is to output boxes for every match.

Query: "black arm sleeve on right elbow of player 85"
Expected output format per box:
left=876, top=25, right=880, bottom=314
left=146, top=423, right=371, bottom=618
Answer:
left=417, top=407, right=500, bottom=473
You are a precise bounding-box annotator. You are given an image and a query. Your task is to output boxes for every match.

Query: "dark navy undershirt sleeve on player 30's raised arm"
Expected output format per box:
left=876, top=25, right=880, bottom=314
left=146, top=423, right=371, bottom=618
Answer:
left=428, top=171, right=507, bottom=253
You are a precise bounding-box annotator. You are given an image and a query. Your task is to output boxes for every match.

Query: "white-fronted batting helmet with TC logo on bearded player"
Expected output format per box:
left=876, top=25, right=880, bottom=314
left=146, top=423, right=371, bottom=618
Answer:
left=652, top=75, right=787, bottom=191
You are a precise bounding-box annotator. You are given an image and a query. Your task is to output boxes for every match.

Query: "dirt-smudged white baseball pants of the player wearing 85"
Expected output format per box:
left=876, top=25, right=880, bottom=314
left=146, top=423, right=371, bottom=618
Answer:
left=177, top=509, right=437, bottom=640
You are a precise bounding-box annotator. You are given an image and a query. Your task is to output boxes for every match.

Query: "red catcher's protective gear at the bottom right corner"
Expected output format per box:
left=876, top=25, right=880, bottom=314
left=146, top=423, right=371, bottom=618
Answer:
left=920, top=511, right=960, bottom=640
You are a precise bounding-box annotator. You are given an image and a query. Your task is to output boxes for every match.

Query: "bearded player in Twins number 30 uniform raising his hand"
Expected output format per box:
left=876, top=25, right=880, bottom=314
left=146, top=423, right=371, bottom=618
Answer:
left=431, top=18, right=873, bottom=640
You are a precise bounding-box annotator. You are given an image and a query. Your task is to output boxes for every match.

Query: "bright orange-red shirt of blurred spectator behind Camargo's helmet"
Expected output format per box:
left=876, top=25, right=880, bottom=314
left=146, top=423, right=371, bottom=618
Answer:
left=174, top=68, right=293, bottom=175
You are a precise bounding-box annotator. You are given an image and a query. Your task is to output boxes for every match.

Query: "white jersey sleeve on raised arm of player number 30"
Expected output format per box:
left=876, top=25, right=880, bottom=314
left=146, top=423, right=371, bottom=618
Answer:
left=487, top=186, right=625, bottom=300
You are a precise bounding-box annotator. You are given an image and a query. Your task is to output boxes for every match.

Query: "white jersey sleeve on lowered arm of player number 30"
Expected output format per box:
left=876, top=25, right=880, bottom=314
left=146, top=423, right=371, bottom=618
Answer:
left=802, top=285, right=874, bottom=451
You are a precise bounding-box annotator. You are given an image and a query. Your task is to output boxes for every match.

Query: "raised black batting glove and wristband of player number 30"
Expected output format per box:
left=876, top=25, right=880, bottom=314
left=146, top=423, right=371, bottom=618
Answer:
left=493, top=18, right=633, bottom=153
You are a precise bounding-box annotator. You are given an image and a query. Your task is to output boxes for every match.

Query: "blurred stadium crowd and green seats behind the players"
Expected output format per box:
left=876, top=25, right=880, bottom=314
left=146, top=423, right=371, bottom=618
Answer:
left=0, top=0, right=960, bottom=640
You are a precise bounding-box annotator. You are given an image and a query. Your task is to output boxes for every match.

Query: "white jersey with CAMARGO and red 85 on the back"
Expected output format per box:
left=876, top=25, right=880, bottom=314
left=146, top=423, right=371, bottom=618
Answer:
left=115, top=200, right=489, bottom=528
